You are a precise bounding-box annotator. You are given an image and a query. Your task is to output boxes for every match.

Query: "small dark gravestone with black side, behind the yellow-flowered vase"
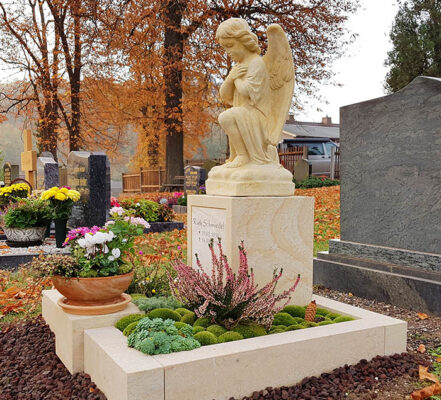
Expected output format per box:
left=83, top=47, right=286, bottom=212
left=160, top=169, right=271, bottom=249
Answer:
left=67, top=151, right=110, bottom=227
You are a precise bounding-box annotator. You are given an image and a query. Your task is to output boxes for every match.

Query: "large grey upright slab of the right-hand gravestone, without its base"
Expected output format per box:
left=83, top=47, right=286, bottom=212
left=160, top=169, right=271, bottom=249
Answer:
left=340, top=77, right=441, bottom=254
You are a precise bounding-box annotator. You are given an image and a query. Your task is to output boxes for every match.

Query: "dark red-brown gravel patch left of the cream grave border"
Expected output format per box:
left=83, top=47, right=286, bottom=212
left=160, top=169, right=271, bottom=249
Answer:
left=0, top=316, right=106, bottom=400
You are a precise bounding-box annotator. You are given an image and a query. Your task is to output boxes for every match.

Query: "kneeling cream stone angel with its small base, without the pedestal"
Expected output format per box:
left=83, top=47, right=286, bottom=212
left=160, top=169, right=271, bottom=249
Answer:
left=206, top=18, right=294, bottom=196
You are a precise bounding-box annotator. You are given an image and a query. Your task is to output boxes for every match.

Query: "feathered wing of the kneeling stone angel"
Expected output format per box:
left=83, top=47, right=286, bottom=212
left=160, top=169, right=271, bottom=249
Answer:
left=263, top=24, right=294, bottom=146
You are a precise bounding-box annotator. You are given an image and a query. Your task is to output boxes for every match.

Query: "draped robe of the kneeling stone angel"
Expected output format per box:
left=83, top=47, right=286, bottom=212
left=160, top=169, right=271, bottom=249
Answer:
left=218, top=56, right=278, bottom=164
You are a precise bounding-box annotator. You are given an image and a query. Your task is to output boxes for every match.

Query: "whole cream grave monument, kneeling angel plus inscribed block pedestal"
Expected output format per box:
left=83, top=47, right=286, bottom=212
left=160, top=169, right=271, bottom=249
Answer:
left=187, top=18, right=314, bottom=305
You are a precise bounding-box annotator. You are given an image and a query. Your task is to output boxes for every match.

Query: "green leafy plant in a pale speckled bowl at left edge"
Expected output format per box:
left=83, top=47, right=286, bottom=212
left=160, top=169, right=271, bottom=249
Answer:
left=2, top=199, right=51, bottom=247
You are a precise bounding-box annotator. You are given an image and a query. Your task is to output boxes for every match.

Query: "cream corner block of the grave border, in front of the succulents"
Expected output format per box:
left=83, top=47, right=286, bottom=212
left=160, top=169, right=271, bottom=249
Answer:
left=84, top=327, right=164, bottom=400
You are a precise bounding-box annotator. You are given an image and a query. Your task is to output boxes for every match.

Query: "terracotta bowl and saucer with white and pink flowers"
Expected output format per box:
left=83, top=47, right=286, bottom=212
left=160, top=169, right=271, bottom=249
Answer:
left=42, top=216, right=146, bottom=315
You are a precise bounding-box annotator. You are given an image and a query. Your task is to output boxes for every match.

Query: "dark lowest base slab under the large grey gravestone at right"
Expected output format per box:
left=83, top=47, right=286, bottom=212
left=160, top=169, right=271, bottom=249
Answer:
left=314, top=253, right=441, bottom=315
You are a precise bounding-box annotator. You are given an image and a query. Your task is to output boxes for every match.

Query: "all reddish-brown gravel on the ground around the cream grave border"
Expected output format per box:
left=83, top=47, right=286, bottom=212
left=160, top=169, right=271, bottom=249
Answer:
left=0, top=288, right=441, bottom=400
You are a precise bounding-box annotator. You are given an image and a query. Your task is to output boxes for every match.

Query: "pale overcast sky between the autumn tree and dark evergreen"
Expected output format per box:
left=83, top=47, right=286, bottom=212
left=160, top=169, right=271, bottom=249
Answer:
left=295, top=0, right=398, bottom=122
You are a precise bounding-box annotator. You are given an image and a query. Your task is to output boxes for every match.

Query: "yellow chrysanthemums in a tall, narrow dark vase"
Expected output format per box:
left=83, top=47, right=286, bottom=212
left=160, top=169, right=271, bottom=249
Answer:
left=41, top=186, right=80, bottom=248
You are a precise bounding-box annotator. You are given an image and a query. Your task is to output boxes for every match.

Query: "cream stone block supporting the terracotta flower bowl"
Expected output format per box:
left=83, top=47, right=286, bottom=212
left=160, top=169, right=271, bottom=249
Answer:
left=42, top=289, right=139, bottom=374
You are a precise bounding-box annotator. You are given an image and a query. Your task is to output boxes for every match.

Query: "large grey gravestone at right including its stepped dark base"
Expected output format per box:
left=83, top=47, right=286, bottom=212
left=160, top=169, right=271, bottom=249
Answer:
left=314, top=77, right=441, bottom=314
